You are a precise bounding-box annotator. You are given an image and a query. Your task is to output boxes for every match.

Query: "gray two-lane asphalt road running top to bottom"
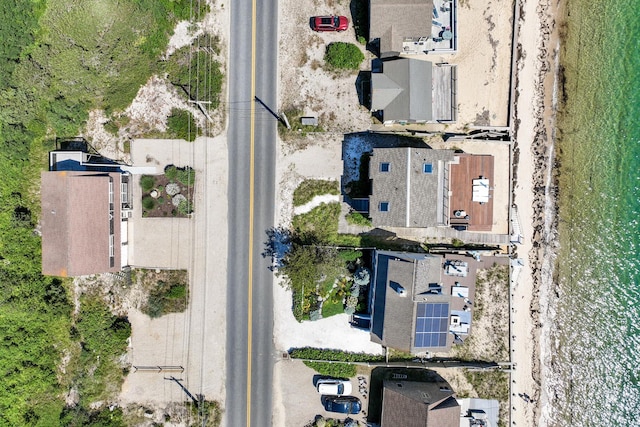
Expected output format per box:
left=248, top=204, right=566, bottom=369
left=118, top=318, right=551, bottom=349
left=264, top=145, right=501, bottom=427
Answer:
left=228, top=0, right=278, bottom=427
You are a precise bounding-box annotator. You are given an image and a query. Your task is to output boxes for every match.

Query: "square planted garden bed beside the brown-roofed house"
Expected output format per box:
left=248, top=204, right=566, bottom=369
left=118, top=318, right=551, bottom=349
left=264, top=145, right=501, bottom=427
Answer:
left=140, top=165, right=195, bottom=218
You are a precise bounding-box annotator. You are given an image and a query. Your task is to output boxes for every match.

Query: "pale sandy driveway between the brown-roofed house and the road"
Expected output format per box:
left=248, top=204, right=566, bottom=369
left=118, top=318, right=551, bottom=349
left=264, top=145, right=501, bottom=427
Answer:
left=121, top=137, right=227, bottom=407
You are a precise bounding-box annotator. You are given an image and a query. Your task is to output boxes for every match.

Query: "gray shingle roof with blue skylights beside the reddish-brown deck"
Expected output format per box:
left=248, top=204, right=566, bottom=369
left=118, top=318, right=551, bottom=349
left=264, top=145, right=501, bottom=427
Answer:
left=369, top=147, right=454, bottom=227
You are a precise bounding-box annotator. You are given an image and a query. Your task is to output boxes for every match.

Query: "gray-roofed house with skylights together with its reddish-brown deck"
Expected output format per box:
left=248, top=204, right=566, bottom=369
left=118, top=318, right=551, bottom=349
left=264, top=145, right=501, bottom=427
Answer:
left=368, top=147, right=493, bottom=231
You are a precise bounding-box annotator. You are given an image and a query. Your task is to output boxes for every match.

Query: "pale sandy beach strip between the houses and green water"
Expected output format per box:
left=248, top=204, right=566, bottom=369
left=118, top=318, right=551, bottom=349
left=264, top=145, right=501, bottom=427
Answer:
left=505, top=0, right=563, bottom=426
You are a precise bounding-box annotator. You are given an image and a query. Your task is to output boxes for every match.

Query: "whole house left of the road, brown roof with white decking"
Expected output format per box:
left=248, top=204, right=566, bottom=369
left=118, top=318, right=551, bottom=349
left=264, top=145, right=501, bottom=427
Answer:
left=41, top=142, right=131, bottom=277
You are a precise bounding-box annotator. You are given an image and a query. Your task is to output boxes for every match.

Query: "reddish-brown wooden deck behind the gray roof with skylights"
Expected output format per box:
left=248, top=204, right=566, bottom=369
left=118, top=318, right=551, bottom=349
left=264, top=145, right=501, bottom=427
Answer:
left=449, top=154, right=494, bottom=231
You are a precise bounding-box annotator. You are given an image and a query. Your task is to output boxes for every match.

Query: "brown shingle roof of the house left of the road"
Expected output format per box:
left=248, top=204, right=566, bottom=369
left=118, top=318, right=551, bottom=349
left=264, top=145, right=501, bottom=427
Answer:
left=41, top=171, right=121, bottom=277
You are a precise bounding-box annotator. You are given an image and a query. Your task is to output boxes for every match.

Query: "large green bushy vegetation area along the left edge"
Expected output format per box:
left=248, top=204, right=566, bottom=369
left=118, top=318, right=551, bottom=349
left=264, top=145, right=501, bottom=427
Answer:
left=0, top=0, right=200, bottom=426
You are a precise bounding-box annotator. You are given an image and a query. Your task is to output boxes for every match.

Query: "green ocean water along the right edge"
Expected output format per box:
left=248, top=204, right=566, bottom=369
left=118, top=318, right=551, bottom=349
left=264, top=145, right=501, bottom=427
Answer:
left=545, top=0, right=640, bottom=426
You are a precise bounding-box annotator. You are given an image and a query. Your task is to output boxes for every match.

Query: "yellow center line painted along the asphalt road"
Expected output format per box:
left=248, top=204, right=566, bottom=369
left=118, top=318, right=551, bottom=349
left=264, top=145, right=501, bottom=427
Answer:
left=247, top=0, right=256, bottom=427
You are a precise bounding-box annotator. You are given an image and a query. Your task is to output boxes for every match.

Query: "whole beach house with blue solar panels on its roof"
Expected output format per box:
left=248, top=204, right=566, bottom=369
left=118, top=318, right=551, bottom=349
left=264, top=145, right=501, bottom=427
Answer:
left=370, top=251, right=477, bottom=354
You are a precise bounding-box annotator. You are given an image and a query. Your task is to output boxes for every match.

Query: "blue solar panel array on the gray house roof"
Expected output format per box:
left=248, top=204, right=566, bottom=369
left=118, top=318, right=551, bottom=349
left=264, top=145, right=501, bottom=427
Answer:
left=414, top=303, right=449, bottom=347
